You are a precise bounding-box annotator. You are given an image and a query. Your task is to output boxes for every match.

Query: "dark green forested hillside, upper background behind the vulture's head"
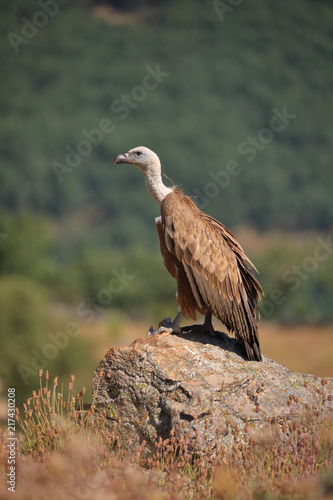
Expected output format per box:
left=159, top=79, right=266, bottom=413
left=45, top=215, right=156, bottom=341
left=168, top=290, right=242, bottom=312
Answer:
left=0, top=0, right=333, bottom=230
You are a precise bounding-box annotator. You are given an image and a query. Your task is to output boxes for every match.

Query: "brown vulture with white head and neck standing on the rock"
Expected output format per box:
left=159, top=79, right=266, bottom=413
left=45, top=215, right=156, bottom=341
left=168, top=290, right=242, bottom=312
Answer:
left=114, top=146, right=263, bottom=361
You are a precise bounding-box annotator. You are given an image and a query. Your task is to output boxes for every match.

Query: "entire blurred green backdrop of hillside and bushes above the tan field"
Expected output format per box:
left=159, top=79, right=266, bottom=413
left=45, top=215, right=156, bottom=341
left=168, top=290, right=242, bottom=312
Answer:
left=0, top=0, right=333, bottom=402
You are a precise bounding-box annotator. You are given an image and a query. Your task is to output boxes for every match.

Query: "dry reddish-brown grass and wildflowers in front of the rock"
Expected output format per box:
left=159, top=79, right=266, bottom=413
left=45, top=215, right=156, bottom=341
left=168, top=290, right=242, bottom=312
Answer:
left=0, top=371, right=333, bottom=500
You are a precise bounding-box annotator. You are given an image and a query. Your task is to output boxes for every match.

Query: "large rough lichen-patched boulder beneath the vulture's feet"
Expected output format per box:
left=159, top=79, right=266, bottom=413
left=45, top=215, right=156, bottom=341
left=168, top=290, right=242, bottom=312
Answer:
left=93, top=331, right=333, bottom=450
